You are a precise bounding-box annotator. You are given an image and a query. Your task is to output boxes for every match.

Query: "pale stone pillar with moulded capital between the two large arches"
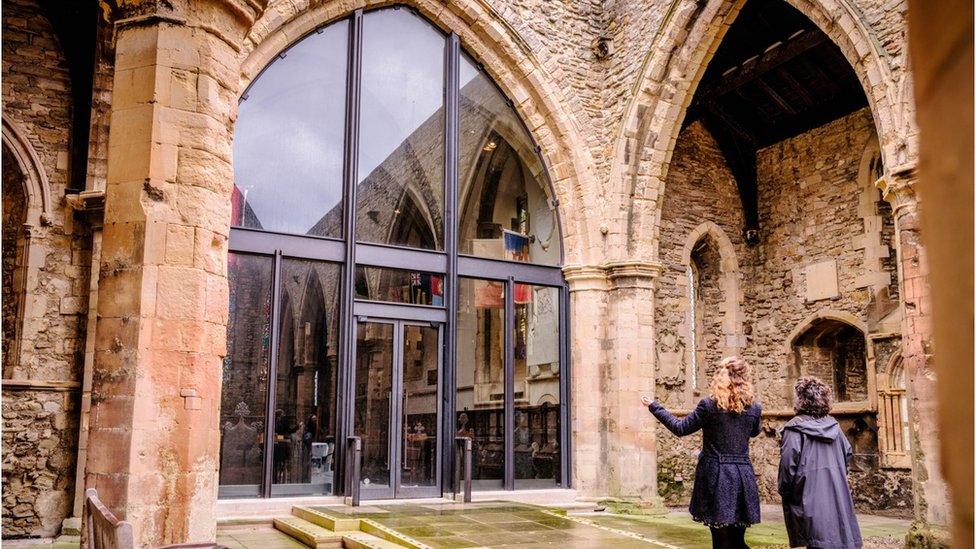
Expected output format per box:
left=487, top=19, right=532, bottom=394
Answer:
left=564, top=262, right=662, bottom=510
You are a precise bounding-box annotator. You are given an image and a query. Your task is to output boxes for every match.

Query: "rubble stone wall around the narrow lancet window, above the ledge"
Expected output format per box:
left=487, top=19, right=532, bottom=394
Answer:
left=654, top=122, right=750, bottom=409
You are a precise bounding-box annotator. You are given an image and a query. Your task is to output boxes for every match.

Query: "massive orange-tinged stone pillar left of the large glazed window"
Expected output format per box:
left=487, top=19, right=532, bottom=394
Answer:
left=79, top=0, right=260, bottom=547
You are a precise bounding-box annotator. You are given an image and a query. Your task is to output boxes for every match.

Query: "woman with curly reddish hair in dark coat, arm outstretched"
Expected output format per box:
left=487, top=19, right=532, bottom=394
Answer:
left=641, top=357, right=761, bottom=549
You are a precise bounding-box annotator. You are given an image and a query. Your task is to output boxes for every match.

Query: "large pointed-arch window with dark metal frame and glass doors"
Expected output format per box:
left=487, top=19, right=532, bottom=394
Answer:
left=220, top=7, right=569, bottom=498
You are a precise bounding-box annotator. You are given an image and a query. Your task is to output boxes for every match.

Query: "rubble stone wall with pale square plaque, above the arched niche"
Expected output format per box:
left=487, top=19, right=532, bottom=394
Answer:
left=746, top=109, right=897, bottom=398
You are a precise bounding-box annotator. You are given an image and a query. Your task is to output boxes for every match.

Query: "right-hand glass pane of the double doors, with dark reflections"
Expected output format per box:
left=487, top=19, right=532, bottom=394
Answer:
left=400, top=324, right=440, bottom=487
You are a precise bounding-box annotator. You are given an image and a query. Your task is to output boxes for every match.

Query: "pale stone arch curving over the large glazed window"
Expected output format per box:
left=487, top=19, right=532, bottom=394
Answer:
left=240, top=0, right=602, bottom=265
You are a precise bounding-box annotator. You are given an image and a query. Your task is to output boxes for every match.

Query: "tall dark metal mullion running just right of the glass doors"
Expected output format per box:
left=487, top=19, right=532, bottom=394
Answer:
left=438, top=33, right=461, bottom=490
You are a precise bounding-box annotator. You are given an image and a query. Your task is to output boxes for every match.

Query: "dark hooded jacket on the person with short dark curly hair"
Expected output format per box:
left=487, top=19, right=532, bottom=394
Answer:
left=778, top=416, right=863, bottom=549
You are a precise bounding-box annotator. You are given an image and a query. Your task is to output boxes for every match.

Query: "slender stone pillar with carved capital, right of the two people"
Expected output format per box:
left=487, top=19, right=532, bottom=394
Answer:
left=878, top=169, right=948, bottom=536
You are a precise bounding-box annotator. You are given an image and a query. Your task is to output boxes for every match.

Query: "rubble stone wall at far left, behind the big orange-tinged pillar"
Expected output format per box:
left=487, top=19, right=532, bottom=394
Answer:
left=3, top=0, right=91, bottom=538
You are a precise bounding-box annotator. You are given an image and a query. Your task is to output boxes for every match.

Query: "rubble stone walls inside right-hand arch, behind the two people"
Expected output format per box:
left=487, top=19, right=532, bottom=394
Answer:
left=655, top=109, right=912, bottom=515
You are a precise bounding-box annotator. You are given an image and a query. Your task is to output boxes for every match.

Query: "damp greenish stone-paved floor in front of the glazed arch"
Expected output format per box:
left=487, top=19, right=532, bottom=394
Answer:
left=4, top=502, right=908, bottom=549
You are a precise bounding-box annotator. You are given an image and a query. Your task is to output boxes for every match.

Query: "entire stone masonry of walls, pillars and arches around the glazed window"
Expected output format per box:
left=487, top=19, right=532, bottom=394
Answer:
left=3, top=0, right=949, bottom=545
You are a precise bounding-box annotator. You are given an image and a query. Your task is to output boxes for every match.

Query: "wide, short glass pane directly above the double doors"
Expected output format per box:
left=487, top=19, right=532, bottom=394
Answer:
left=356, top=266, right=444, bottom=307
